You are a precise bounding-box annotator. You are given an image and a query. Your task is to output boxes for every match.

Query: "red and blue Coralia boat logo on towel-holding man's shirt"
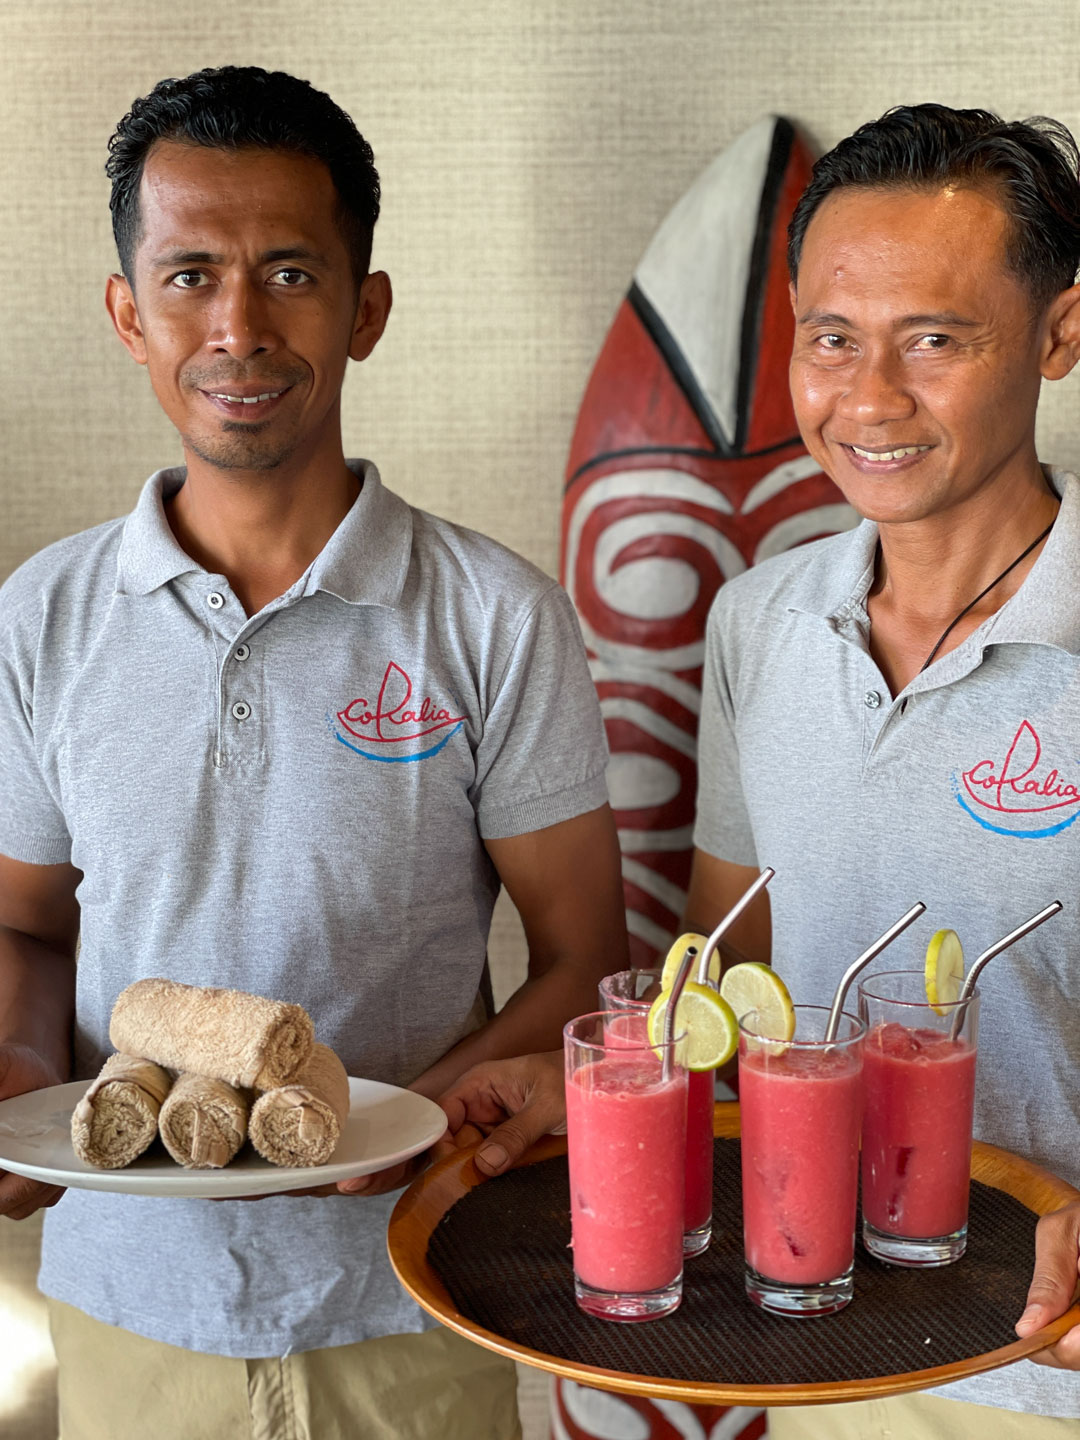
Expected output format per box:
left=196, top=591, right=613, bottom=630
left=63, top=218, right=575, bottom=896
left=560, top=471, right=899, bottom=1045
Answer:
left=327, top=661, right=465, bottom=765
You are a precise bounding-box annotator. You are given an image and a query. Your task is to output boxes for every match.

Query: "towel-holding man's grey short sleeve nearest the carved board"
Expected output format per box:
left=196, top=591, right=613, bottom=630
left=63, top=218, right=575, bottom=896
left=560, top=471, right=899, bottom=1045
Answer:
left=472, top=585, right=608, bottom=840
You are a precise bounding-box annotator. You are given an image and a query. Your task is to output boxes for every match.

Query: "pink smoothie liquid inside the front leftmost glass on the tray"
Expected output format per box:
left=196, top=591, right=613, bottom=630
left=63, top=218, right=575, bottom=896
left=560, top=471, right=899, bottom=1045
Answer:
left=566, top=1050, right=687, bottom=1292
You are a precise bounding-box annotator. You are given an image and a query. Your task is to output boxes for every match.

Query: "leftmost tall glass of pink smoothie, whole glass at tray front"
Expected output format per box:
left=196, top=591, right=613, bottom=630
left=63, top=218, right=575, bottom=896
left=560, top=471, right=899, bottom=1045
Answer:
left=563, top=1011, right=687, bottom=1320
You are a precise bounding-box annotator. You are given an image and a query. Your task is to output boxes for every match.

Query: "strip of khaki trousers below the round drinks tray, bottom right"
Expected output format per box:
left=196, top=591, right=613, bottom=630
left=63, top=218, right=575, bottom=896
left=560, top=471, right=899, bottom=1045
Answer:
left=769, top=1377, right=1080, bottom=1440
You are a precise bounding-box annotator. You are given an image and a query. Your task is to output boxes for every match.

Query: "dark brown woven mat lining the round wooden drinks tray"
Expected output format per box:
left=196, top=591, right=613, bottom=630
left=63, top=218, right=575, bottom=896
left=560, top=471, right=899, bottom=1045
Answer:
left=428, top=1140, right=1037, bottom=1385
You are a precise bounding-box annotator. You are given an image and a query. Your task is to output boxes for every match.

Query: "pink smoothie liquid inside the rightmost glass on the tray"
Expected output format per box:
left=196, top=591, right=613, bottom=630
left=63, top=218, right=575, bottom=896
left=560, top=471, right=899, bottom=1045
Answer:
left=863, top=1022, right=976, bottom=1240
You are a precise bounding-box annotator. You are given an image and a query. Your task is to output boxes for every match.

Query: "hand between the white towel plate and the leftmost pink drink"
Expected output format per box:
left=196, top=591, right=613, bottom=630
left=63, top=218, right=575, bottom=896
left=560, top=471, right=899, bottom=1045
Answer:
left=435, top=1050, right=566, bottom=1175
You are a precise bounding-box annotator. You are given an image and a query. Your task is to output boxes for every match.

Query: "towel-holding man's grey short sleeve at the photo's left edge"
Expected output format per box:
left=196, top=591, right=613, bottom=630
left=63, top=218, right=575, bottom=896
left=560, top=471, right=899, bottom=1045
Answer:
left=0, top=592, right=71, bottom=865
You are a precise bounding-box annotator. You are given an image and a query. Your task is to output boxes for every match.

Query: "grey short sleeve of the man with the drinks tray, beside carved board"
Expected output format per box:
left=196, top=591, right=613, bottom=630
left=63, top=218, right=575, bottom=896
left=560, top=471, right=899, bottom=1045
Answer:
left=694, top=605, right=757, bottom=865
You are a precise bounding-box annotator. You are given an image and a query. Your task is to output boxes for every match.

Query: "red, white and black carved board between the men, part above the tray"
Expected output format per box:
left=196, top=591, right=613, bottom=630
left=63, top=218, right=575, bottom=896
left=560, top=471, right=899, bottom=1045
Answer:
left=562, top=121, right=854, bottom=965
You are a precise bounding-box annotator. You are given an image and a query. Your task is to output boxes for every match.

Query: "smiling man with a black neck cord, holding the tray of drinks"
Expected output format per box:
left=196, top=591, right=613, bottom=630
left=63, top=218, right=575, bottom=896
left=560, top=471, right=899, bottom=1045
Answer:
left=688, top=105, right=1080, bottom=1440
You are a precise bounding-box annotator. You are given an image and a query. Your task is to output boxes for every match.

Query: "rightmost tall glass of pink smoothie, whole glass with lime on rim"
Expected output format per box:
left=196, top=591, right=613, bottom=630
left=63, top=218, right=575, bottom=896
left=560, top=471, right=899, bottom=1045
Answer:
left=858, top=971, right=979, bottom=1266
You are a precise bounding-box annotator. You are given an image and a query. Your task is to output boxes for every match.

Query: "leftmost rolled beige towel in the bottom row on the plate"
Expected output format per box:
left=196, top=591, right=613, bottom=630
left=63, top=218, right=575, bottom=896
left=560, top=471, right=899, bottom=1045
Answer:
left=71, top=1053, right=173, bottom=1169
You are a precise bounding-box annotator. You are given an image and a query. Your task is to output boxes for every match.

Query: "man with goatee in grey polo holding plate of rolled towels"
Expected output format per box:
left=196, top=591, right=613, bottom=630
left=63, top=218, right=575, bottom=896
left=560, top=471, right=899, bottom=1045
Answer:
left=0, top=69, right=625, bottom=1440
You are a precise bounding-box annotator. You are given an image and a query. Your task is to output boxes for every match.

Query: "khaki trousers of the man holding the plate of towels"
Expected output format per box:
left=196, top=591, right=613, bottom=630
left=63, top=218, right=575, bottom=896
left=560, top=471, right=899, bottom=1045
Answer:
left=48, top=1300, right=521, bottom=1440
